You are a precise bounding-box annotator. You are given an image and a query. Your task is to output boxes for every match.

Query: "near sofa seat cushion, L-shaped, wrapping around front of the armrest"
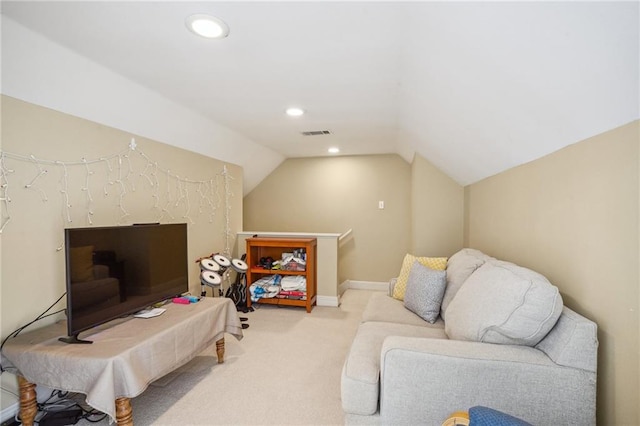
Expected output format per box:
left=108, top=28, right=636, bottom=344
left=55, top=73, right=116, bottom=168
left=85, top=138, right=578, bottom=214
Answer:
left=340, top=322, right=447, bottom=415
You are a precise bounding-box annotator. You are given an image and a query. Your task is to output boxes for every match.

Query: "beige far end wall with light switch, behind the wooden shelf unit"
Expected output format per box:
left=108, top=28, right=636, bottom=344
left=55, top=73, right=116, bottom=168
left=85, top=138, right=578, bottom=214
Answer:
left=244, top=155, right=411, bottom=282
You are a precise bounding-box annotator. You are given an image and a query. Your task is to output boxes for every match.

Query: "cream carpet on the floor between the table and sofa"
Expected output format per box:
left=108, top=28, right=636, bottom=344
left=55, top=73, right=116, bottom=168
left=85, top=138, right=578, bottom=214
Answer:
left=78, top=289, right=373, bottom=426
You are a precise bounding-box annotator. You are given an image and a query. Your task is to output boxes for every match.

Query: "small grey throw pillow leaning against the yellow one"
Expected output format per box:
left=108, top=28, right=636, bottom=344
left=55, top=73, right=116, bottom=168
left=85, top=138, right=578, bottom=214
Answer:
left=404, top=261, right=447, bottom=324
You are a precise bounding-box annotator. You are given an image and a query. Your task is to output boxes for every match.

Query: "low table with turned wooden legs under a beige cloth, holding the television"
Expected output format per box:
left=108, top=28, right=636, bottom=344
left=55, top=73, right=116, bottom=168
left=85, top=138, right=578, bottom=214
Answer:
left=2, top=297, right=242, bottom=426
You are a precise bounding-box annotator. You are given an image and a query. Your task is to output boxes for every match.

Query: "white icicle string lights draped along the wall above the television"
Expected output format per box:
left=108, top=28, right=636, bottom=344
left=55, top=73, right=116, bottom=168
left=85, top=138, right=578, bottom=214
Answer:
left=0, top=139, right=234, bottom=245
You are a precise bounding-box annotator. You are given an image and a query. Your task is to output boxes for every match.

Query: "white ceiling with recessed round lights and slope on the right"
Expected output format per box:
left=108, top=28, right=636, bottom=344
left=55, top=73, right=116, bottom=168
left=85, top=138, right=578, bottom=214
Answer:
left=2, top=1, right=640, bottom=188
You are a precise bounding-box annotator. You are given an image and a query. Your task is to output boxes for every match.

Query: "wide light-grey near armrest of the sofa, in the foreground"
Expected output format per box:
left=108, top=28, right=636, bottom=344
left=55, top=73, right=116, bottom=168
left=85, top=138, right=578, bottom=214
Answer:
left=380, top=336, right=596, bottom=425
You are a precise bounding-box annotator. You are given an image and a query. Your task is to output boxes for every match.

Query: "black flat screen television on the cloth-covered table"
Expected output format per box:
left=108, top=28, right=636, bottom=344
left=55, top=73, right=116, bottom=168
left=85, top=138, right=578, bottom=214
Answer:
left=60, top=223, right=189, bottom=343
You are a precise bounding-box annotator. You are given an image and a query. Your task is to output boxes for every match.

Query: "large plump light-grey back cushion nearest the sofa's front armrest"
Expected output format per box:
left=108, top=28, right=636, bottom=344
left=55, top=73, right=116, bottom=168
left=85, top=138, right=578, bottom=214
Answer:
left=445, top=260, right=563, bottom=346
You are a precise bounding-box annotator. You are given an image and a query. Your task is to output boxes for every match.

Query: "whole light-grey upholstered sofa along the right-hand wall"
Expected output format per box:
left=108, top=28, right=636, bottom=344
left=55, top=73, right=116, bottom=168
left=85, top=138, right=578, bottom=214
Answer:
left=341, top=249, right=598, bottom=425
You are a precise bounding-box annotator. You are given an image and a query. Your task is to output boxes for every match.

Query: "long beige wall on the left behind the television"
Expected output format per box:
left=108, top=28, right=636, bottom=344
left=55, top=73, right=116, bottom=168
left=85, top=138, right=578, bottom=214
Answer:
left=0, top=96, right=242, bottom=352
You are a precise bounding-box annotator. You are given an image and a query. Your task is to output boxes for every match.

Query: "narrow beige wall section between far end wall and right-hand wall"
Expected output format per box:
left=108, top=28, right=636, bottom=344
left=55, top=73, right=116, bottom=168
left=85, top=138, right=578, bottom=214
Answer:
left=411, top=154, right=464, bottom=257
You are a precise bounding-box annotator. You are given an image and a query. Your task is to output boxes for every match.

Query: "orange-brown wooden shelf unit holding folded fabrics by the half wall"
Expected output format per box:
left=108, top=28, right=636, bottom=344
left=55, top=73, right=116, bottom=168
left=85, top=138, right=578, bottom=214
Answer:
left=246, top=237, right=317, bottom=312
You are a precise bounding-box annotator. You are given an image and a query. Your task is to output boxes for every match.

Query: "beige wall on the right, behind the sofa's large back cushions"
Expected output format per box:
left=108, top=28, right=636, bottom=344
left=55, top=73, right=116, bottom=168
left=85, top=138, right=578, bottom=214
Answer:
left=465, top=121, right=640, bottom=425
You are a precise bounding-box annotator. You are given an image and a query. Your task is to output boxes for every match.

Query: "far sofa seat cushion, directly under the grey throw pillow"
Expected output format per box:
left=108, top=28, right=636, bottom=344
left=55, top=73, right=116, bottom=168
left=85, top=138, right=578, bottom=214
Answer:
left=362, top=292, right=444, bottom=329
